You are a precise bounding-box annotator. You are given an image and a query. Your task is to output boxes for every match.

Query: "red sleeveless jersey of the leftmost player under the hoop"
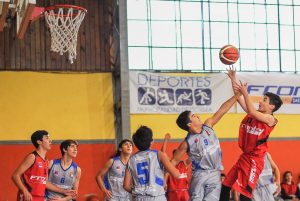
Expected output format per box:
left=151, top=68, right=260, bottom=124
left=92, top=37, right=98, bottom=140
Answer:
left=18, top=151, right=48, bottom=197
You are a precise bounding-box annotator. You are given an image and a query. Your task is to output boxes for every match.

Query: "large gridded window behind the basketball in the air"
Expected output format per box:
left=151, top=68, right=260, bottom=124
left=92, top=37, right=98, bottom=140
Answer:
left=127, top=0, right=300, bottom=73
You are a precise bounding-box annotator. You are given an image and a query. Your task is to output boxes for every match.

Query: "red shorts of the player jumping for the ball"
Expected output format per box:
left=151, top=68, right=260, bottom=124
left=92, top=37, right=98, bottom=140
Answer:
left=223, top=154, right=264, bottom=198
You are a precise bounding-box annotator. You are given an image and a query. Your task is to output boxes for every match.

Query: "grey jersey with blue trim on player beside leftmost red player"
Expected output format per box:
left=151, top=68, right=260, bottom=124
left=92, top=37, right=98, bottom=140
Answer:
left=45, top=159, right=78, bottom=200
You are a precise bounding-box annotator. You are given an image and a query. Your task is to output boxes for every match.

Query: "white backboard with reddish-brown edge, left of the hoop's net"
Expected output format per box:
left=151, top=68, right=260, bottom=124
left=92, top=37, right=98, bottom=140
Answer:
left=15, top=0, right=36, bottom=39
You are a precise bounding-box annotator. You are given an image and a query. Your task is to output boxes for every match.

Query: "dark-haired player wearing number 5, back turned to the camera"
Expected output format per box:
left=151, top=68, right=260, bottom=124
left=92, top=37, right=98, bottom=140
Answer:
left=123, top=126, right=180, bottom=201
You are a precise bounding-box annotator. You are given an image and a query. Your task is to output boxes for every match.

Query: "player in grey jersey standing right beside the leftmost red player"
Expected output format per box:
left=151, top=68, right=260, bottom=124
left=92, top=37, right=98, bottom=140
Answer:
left=45, top=140, right=81, bottom=201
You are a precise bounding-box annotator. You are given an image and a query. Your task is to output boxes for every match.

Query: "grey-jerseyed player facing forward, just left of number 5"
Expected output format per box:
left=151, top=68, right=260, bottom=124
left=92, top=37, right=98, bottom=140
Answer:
left=96, top=139, right=133, bottom=201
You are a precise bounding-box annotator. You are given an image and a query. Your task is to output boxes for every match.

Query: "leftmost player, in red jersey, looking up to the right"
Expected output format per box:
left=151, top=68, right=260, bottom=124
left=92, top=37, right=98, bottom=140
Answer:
left=12, top=130, right=73, bottom=201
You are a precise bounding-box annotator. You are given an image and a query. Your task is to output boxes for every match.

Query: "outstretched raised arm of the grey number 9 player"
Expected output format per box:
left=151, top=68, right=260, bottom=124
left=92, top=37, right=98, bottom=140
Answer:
left=204, top=93, right=240, bottom=128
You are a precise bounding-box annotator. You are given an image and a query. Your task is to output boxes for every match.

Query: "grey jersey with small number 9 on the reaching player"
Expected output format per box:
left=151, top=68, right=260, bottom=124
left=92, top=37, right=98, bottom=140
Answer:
left=185, top=125, right=223, bottom=171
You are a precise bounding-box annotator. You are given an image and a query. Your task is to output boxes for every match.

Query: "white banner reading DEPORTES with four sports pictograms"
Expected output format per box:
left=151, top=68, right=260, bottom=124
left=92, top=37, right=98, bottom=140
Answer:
left=130, top=71, right=235, bottom=114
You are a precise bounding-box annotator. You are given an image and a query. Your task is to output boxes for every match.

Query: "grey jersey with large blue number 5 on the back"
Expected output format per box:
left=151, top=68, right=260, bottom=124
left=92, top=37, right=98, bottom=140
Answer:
left=128, top=150, right=165, bottom=197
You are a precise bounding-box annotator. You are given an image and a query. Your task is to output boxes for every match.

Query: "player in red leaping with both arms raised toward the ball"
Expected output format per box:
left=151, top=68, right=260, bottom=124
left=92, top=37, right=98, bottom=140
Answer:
left=220, top=68, right=282, bottom=201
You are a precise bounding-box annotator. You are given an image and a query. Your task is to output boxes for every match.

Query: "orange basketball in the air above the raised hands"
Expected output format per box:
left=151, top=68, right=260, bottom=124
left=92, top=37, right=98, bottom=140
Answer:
left=219, top=45, right=240, bottom=65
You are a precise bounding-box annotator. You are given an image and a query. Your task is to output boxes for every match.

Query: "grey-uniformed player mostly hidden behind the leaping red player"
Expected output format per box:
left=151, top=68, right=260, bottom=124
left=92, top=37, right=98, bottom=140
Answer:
left=252, top=152, right=280, bottom=201
